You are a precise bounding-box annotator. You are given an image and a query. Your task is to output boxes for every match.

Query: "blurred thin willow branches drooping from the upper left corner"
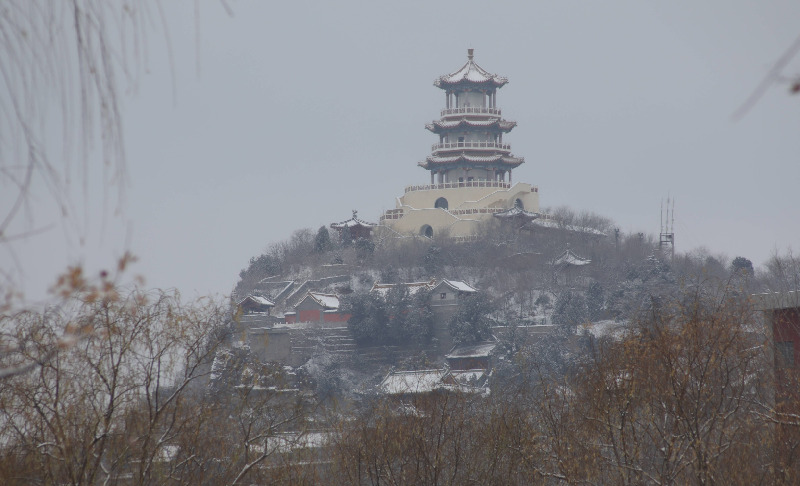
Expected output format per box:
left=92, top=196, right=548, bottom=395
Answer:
left=0, top=0, right=174, bottom=247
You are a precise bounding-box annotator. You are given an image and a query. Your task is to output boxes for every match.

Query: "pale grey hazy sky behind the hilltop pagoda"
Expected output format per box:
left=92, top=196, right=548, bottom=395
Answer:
left=0, top=0, right=800, bottom=298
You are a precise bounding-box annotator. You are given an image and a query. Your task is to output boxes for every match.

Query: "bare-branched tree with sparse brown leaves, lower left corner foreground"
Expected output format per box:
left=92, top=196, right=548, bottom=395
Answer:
left=0, top=288, right=226, bottom=484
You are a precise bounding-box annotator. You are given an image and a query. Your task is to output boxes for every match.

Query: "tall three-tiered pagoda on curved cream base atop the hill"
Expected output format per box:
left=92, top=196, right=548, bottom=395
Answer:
left=381, top=49, right=539, bottom=238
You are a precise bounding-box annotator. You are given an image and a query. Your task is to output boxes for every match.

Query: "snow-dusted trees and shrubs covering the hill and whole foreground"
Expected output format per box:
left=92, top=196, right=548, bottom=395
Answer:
left=0, top=209, right=800, bottom=485
